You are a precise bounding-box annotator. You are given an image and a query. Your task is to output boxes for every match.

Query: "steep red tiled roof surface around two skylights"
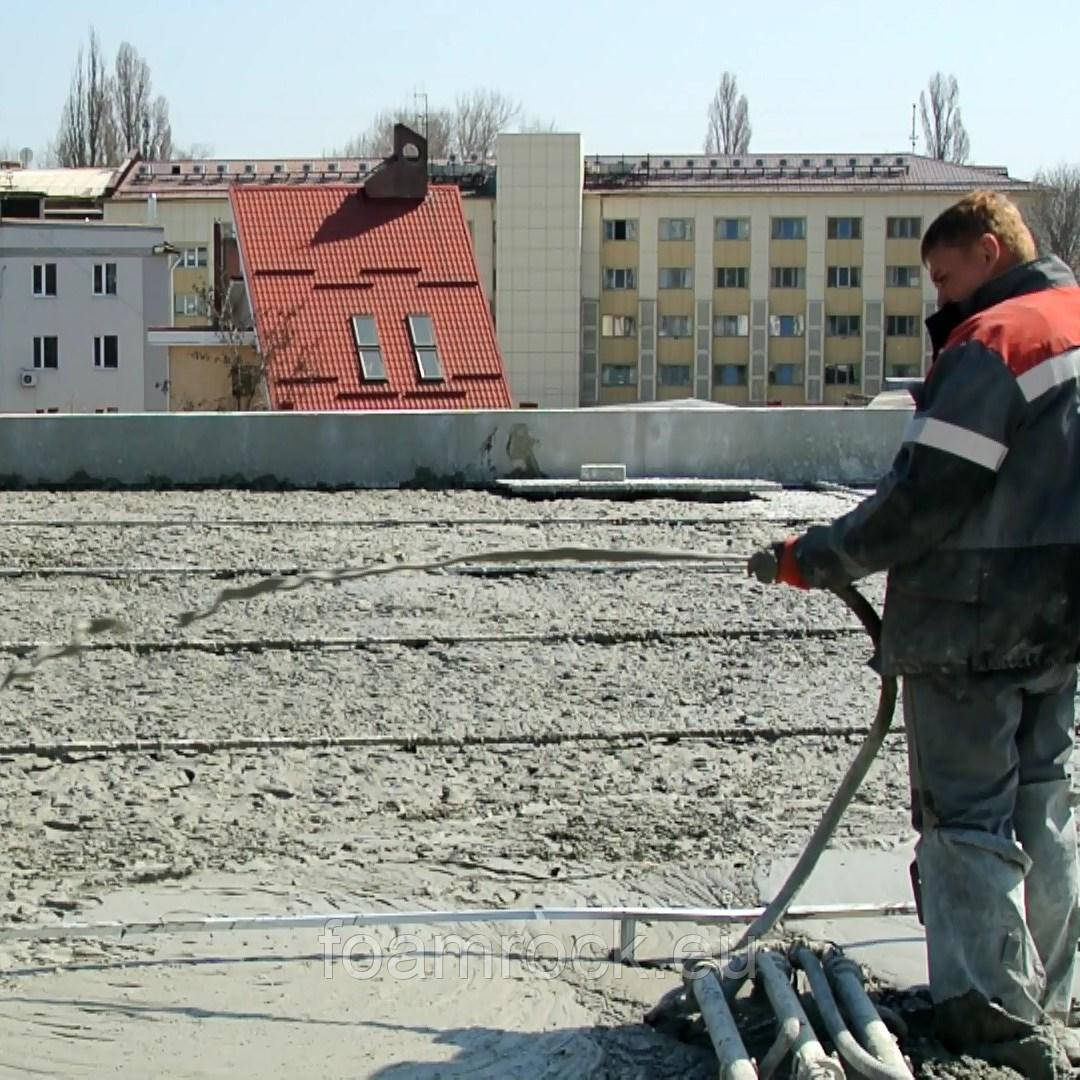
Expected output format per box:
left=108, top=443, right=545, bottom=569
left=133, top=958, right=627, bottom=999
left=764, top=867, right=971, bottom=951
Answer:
left=230, top=185, right=511, bottom=410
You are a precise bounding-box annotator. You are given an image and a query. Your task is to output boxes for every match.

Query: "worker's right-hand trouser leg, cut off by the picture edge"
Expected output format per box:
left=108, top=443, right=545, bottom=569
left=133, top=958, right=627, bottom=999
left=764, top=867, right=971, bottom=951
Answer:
left=1013, top=664, right=1080, bottom=1023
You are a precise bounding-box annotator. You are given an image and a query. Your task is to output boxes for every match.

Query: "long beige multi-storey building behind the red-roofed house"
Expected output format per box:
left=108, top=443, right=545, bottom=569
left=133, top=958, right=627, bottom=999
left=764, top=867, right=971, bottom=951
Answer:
left=105, top=142, right=1032, bottom=407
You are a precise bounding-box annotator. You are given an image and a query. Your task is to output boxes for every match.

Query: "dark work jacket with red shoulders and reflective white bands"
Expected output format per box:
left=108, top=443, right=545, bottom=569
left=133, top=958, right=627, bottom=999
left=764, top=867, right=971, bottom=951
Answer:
left=795, top=258, right=1080, bottom=675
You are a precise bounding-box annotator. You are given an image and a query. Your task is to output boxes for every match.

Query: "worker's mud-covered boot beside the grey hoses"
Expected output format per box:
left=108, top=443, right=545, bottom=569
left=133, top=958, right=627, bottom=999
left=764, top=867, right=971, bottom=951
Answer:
left=934, top=990, right=1080, bottom=1080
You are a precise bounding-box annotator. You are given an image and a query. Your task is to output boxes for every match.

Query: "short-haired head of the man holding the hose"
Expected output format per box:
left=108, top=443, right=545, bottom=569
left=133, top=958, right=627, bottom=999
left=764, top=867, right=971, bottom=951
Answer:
left=921, top=191, right=1036, bottom=305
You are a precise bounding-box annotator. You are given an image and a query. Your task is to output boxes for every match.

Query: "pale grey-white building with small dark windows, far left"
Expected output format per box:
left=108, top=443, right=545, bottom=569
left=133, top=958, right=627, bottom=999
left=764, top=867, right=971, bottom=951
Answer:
left=0, top=218, right=171, bottom=413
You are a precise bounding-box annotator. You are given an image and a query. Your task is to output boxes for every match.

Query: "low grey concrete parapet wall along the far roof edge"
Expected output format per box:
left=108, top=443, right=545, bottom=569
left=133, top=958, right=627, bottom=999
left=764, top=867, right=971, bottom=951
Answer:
left=0, top=408, right=910, bottom=487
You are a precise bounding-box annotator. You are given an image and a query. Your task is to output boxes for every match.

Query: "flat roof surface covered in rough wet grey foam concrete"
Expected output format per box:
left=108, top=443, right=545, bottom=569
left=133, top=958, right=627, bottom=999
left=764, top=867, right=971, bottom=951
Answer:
left=0, top=489, right=1049, bottom=1080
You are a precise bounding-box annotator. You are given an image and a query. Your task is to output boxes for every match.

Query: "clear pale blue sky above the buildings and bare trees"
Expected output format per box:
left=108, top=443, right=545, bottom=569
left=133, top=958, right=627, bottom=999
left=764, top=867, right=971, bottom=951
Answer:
left=0, top=0, right=1080, bottom=176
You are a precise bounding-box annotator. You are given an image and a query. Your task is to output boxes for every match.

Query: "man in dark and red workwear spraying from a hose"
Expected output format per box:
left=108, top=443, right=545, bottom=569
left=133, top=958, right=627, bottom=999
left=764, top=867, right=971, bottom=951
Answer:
left=751, top=191, right=1080, bottom=1077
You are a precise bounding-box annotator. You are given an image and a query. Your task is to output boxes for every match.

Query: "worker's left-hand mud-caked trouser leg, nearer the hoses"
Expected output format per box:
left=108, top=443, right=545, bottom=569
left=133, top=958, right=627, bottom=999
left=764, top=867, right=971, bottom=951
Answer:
left=904, top=673, right=1045, bottom=1023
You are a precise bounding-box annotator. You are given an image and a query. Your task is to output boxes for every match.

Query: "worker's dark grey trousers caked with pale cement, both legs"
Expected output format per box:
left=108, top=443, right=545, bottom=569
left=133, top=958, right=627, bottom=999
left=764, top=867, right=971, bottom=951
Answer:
left=904, top=664, right=1080, bottom=1024
